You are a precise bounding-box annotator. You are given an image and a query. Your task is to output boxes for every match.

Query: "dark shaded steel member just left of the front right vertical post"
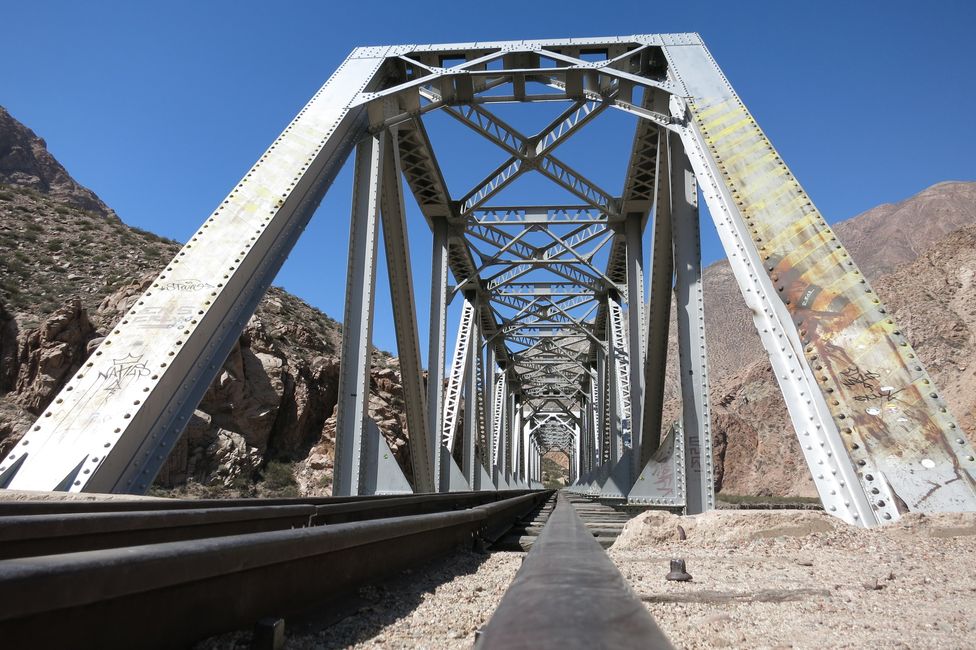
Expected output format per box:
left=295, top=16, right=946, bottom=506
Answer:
left=640, top=124, right=674, bottom=469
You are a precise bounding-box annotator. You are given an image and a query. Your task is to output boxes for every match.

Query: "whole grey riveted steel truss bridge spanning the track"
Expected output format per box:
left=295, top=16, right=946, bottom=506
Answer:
left=0, top=34, right=976, bottom=526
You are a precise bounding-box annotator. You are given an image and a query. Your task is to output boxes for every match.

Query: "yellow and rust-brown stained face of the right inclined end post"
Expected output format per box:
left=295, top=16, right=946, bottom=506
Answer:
left=693, top=98, right=974, bottom=508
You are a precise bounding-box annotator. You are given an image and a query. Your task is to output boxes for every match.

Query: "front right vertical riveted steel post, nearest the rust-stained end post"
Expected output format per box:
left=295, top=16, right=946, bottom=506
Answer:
left=670, top=138, right=715, bottom=514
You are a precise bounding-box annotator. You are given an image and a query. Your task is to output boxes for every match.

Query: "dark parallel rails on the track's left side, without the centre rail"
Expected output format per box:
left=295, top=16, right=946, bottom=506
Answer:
left=0, top=490, right=552, bottom=649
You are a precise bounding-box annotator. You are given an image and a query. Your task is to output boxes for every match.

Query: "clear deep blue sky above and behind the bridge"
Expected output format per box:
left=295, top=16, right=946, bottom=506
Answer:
left=0, top=0, right=976, bottom=350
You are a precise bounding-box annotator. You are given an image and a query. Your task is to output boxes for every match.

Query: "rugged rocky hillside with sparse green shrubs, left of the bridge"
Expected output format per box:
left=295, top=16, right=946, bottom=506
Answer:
left=0, top=108, right=410, bottom=495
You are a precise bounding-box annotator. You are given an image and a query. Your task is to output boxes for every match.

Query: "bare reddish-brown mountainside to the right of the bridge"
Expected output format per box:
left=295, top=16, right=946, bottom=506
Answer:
left=692, top=182, right=976, bottom=496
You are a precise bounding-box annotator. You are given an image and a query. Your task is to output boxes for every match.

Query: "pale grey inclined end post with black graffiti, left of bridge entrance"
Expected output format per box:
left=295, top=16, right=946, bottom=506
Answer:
left=0, top=48, right=386, bottom=492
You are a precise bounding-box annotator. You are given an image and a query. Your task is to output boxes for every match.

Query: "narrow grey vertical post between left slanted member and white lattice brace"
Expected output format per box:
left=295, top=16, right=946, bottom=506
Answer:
left=427, top=217, right=447, bottom=490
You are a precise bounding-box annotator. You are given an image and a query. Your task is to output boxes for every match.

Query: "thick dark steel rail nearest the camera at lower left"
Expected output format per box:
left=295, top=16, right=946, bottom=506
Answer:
left=0, top=491, right=551, bottom=649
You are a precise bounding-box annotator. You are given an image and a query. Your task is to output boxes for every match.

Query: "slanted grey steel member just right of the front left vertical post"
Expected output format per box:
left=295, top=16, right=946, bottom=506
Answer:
left=381, top=128, right=430, bottom=492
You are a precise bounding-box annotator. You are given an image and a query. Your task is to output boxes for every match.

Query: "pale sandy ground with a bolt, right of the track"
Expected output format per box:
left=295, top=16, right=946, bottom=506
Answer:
left=610, top=510, right=976, bottom=650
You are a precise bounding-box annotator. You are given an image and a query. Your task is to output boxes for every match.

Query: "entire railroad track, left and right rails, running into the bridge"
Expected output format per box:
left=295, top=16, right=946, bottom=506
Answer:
left=0, top=490, right=670, bottom=649
